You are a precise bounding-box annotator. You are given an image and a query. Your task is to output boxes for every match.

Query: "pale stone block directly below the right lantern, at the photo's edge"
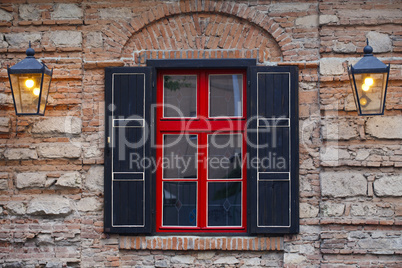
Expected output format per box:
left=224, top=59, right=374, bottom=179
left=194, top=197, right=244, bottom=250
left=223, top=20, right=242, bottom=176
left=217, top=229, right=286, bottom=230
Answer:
left=366, top=116, right=402, bottom=139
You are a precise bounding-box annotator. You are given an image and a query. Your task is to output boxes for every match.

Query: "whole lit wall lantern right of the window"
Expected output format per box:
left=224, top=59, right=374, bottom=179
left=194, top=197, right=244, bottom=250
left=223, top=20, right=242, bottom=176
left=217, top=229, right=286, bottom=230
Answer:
left=348, top=40, right=390, bottom=115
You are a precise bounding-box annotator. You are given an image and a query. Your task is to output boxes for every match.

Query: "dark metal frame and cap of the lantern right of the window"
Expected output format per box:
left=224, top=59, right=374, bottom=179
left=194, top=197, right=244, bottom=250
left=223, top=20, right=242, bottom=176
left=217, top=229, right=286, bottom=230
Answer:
left=348, top=40, right=390, bottom=116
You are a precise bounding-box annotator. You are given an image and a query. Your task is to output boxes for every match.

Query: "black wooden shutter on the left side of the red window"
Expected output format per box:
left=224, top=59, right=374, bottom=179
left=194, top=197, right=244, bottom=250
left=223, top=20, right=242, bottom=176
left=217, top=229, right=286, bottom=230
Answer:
left=105, top=67, right=152, bottom=233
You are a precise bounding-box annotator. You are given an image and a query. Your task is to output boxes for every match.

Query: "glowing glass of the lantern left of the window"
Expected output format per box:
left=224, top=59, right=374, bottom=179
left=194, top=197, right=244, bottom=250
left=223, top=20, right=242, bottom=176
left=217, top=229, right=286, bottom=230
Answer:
left=10, top=73, right=42, bottom=114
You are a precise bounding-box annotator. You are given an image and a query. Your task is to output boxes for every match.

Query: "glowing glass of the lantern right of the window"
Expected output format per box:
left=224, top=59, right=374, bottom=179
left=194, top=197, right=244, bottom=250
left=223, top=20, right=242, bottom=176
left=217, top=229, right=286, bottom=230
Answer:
left=353, top=73, right=387, bottom=115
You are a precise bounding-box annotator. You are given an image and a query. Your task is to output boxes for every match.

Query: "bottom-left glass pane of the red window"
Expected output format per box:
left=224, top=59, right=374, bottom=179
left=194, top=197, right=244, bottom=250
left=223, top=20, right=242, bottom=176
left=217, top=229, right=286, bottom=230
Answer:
left=163, top=182, right=197, bottom=226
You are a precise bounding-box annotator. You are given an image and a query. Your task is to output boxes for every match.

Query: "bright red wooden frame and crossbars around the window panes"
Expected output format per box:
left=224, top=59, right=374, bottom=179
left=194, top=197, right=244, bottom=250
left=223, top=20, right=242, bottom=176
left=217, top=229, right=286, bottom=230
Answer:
left=156, top=69, right=247, bottom=233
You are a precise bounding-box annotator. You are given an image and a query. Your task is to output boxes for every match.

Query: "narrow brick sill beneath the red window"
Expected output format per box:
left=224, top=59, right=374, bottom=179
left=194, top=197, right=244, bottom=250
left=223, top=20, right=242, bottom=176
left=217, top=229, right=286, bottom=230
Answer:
left=119, top=236, right=283, bottom=251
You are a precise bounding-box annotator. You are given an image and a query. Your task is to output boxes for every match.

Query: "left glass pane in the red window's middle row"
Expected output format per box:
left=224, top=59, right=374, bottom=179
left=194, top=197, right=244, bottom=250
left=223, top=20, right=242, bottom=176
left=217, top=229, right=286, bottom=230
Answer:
left=163, top=135, right=197, bottom=179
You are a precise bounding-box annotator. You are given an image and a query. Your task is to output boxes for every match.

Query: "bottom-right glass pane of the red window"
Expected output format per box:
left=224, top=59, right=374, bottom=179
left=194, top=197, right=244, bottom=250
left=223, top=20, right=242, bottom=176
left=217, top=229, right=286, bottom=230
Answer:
left=208, top=182, right=241, bottom=226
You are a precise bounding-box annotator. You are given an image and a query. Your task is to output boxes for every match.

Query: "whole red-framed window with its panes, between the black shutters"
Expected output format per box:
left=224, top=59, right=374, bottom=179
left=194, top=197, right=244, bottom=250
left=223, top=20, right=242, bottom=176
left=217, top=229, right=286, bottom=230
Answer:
left=156, top=70, right=247, bottom=232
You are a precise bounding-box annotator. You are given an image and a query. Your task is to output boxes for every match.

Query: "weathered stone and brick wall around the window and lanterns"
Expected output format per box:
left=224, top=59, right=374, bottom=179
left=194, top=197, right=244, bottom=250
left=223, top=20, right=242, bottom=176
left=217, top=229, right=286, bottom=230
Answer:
left=0, top=0, right=402, bottom=267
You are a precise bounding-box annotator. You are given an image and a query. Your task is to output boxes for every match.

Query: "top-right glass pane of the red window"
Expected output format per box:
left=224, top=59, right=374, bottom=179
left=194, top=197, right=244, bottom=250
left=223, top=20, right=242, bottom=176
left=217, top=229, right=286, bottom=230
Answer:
left=209, top=74, right=243, bottom=117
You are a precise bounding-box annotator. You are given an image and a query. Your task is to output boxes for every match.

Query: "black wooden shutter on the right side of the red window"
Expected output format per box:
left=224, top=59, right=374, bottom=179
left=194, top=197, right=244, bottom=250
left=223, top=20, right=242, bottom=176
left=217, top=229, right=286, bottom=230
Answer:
left=247, top=66, right=299, bottom=234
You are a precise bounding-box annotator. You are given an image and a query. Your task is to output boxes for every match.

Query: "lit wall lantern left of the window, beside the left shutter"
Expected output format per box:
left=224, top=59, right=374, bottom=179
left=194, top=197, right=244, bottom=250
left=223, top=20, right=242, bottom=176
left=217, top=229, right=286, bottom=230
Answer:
left=7, top=42, right=53, bottom=116
